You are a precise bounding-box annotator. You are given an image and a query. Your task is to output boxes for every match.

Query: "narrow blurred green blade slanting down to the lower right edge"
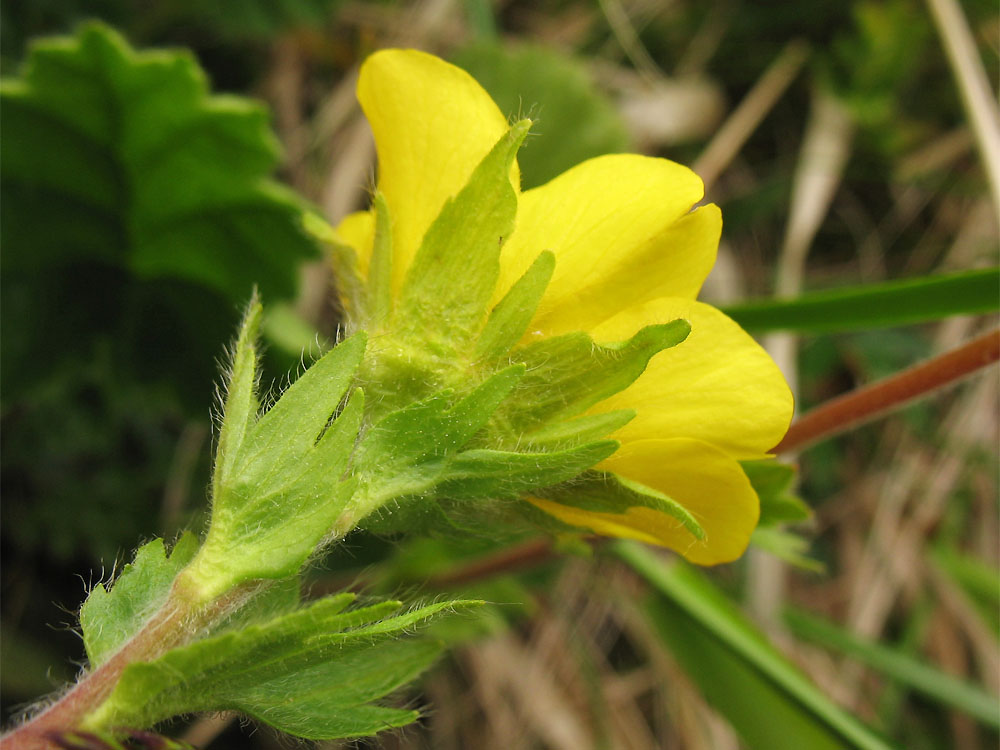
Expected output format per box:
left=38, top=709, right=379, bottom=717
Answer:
left=785, top=610, right=1000, bottom=729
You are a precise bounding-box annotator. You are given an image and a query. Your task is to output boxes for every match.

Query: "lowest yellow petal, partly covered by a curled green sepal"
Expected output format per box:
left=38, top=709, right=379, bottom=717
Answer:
left=530, top=439, right=760, bottom=565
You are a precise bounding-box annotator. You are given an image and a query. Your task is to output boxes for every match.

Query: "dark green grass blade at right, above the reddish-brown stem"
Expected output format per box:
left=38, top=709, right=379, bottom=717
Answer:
left=723, top=268, right=1000, bottom=333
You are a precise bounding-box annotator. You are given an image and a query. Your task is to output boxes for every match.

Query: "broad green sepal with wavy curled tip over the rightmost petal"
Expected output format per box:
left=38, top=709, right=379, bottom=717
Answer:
left=502, top=320, right=691, bottom=433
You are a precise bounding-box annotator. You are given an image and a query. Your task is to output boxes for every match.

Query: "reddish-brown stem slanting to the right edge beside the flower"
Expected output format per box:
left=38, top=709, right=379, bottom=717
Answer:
left=774, top=329, right=1000, bottom=453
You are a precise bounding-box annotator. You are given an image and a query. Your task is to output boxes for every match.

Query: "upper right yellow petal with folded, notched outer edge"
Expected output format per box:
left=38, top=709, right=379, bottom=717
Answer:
left=497, top=154, right=722, bottom=335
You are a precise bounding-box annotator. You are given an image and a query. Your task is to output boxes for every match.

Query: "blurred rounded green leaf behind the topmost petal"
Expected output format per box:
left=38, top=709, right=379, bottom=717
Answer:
left=452, top=42, right=629, bottom=188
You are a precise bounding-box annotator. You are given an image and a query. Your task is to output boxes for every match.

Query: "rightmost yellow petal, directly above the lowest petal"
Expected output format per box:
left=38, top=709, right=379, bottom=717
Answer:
left=591, top=299, right=792, bottom=459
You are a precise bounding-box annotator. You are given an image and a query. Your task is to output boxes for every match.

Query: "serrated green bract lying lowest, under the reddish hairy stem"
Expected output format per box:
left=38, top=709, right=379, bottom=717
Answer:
left=84, top=594, right=479, bottom=739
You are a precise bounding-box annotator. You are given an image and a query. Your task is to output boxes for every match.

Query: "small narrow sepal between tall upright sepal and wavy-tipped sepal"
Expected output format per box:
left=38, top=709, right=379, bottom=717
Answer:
left=475, top=250, right=556, bottom=361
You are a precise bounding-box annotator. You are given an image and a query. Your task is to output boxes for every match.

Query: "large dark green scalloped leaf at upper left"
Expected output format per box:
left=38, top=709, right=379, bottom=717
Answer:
left=0, top=23, right=315, bottom=301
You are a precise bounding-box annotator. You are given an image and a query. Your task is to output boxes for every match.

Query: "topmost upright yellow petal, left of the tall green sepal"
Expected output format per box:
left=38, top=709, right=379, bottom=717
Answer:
left=358, top=50, right=519, bottom=291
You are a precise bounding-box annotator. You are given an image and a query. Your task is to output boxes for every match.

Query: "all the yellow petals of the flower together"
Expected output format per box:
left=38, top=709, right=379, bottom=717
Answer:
left=337, top=50, right=792, bottom=564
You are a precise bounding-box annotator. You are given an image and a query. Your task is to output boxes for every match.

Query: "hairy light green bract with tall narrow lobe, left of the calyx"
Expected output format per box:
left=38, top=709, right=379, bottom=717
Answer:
left=185, top=301, right=365, bottom=601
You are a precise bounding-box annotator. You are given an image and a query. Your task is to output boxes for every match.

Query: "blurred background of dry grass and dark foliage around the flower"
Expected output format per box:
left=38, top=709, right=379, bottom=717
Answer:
left=0, top=0, right=1000, bottom=750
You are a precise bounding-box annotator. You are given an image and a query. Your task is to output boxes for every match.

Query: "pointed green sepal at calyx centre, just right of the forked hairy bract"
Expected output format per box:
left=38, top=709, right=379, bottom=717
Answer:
left=354, top=365, right=524, bottom=520
